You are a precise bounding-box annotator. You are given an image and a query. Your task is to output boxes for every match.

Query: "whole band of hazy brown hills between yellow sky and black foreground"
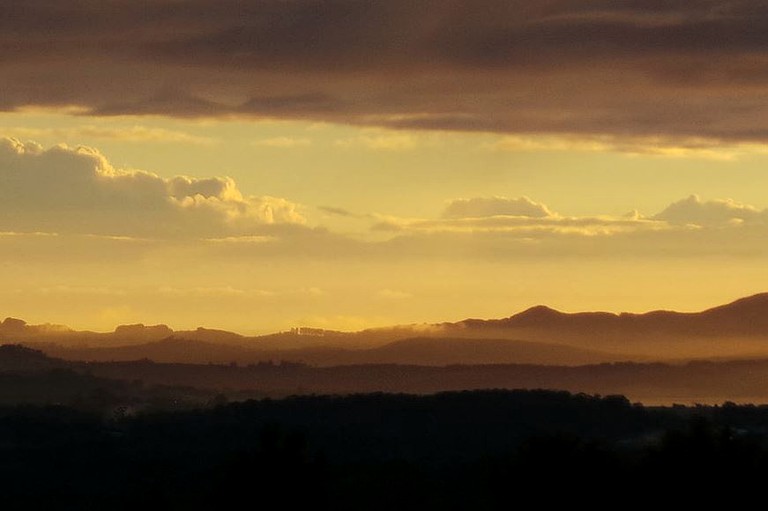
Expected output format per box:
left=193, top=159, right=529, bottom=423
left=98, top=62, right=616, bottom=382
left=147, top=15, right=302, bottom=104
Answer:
left=7, top=294, right=768, bottom=407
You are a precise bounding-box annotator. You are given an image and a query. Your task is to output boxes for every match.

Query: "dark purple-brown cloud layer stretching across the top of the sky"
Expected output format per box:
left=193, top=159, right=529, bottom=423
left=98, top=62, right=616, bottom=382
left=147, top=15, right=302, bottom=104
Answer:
left=0, top=0, right=768, bottom=142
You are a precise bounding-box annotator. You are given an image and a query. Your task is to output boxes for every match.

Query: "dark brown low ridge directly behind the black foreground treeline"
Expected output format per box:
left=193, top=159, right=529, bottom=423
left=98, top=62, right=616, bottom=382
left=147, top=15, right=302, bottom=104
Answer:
left=0, top=345, right=768, bottom=410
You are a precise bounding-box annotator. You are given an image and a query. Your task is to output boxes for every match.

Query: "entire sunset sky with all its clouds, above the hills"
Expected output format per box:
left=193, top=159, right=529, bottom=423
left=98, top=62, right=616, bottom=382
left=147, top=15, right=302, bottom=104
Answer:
left=0, top=0, right=768, bottom=333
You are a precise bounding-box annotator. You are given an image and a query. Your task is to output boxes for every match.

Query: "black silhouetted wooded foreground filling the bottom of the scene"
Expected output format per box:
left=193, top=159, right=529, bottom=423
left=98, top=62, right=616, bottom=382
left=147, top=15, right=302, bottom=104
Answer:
left=0, top=391, right=768, bottom=510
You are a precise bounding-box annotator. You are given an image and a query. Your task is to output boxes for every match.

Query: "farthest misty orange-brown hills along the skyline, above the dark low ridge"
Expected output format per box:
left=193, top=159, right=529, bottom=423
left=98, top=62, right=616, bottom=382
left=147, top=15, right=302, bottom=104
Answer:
left=7, top=293, right=768, bottom=365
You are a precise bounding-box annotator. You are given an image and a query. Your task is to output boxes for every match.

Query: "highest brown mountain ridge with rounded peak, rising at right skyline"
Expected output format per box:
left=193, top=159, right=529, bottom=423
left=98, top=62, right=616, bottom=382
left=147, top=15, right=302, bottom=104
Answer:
left=440, top=293, right=768, bottom=359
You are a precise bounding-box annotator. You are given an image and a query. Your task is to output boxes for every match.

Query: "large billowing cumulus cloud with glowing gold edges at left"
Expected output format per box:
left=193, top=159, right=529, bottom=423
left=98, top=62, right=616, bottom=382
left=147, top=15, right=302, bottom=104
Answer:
left=0, top=138, right=304, bottom=238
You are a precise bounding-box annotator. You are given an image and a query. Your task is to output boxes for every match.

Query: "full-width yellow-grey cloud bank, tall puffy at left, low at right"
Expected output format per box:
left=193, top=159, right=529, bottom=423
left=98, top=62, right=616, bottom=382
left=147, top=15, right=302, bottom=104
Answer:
left=0, top=138, right=768, bottom=264
